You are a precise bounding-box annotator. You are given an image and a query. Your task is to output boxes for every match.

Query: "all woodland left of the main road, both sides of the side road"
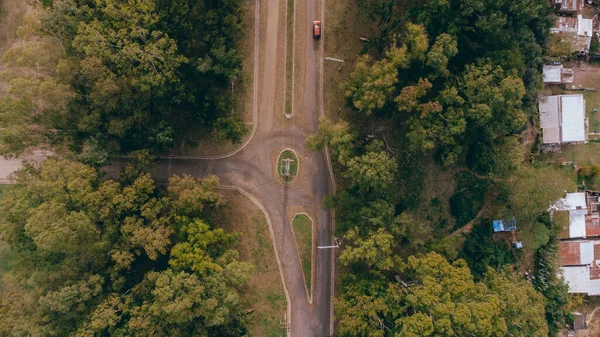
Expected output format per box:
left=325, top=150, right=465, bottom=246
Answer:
left=0, top=0, right=254, bottom=336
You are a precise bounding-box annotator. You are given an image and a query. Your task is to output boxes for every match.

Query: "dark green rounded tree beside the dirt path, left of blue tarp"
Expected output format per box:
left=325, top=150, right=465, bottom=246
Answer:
left=450, top=171, right=488, bottom=228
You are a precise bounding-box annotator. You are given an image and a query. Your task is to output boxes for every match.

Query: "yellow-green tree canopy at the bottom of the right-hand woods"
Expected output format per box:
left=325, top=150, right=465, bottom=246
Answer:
left=338, top=253, right=548, bottom=337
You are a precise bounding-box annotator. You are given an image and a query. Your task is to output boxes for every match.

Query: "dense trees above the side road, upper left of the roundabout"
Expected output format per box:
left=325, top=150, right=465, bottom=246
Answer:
left=0, top=0, right=244, bottom=159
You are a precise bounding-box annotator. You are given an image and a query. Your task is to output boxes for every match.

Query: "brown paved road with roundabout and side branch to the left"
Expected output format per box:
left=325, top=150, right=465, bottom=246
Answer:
left=0, top=0, right=333, bottom=337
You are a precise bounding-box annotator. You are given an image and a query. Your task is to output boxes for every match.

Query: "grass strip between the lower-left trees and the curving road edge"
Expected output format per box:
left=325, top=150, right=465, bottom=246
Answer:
left=212, top=191, right=286, bottom=337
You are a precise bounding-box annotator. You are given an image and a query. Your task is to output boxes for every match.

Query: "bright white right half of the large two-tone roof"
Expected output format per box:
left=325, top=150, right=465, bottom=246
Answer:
left=560, top=94, right=585, bottom=142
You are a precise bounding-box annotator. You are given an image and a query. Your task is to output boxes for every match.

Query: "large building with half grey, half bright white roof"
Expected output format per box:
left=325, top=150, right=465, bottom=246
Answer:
left=539, top=94, right=588, bottom=144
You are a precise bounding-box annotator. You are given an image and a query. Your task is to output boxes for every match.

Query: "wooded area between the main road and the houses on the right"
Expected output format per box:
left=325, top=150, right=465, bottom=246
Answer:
left=306, top=0, right=576, bottom=337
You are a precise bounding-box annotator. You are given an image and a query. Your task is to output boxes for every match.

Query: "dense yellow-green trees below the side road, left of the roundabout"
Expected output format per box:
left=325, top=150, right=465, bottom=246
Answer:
left=0, top=159, right=252, bottom=336
